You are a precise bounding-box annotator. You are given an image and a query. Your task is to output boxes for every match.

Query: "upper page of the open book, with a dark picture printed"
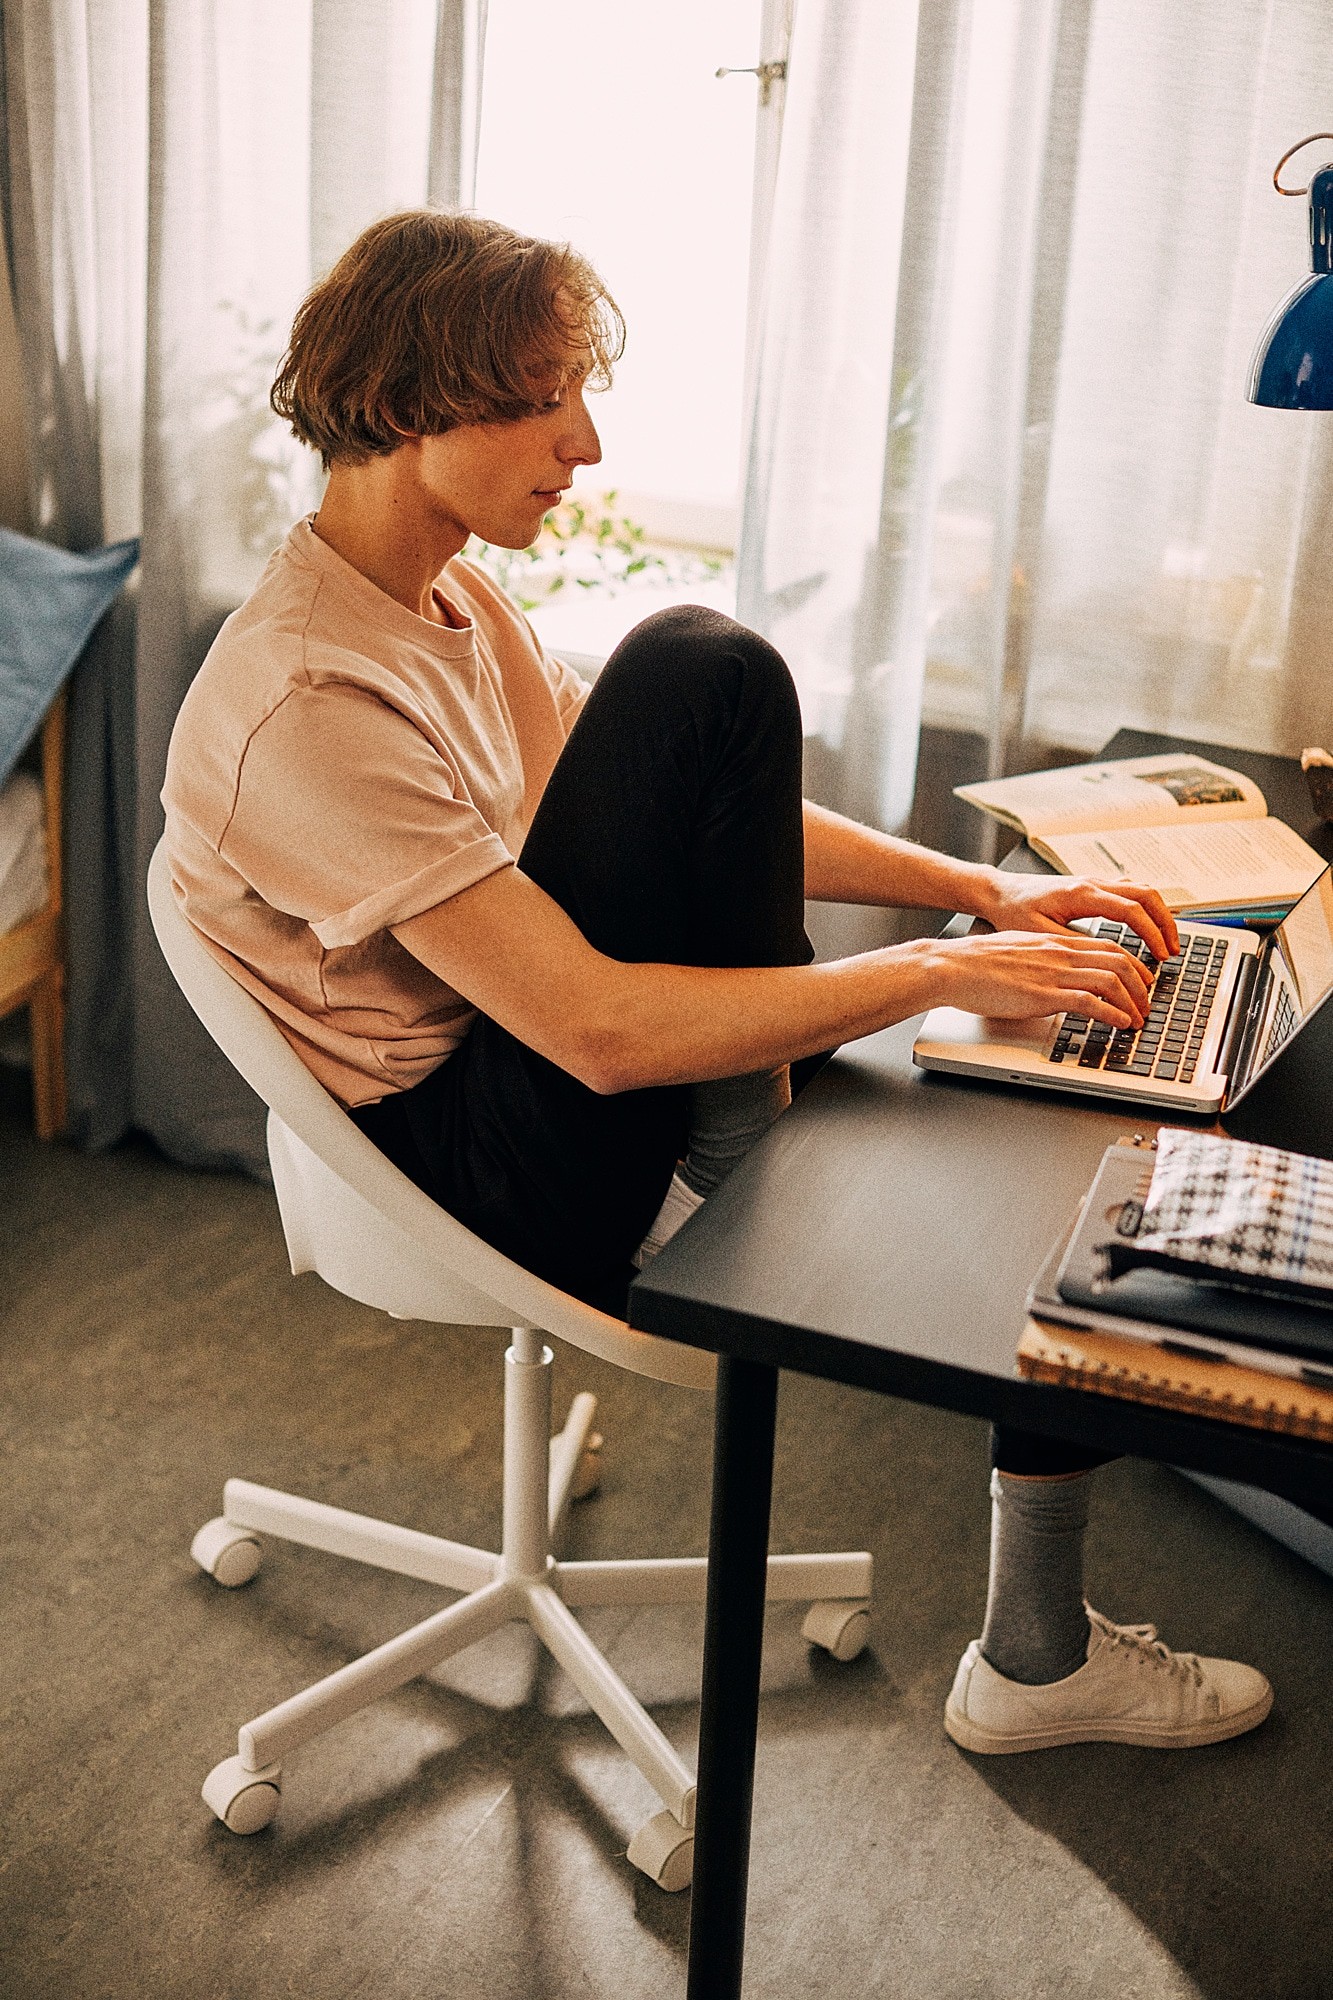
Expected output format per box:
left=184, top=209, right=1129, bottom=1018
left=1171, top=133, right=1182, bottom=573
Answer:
left=955, top=752, right=1269, bottom=834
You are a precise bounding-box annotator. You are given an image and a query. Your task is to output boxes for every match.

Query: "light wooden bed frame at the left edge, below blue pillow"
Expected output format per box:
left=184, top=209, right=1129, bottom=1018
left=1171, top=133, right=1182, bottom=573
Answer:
left=0, top=692, right=66, bottom=1138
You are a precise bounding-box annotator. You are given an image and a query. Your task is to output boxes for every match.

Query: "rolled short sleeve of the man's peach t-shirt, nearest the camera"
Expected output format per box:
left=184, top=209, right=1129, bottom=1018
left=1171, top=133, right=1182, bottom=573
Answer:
left=218, top=684, right=512, bottom=950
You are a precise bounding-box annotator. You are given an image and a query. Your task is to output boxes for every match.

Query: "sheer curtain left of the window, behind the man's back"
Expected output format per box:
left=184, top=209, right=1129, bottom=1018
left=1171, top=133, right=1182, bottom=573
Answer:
left=4, top=0, right=484, bottom=1166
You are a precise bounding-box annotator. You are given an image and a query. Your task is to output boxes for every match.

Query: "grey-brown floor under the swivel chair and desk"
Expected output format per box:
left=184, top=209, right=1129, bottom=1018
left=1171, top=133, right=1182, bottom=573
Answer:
left=0, top=1082, right=1333, bottom=2000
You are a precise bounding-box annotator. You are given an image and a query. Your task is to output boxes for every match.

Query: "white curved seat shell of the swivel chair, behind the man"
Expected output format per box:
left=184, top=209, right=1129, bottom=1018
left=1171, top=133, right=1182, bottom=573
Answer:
left=148, top=842, right=715, bottom=1388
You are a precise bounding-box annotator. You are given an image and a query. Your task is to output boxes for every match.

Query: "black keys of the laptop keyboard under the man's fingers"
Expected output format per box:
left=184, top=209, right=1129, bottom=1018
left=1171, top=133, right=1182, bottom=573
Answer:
left=1051, top=920, right=1227, bottom=1084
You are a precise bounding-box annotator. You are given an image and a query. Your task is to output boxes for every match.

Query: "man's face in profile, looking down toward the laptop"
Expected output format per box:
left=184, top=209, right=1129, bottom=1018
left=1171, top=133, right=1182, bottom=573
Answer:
left=408, top=370, right=602, bottom=548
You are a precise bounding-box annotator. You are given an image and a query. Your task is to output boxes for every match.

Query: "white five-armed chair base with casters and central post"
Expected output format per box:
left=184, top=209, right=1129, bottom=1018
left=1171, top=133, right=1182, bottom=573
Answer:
left=190, top=1328, right=873, bottom=1890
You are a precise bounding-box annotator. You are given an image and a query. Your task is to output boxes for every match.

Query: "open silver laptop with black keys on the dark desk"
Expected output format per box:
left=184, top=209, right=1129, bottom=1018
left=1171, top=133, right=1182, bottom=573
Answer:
left=913, top=868, right=1333, bottom=1112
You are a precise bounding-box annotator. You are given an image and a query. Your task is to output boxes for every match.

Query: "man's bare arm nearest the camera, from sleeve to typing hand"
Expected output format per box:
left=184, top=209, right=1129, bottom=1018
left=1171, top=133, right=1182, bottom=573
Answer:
left=392, top=868, right=1147, bottom=1092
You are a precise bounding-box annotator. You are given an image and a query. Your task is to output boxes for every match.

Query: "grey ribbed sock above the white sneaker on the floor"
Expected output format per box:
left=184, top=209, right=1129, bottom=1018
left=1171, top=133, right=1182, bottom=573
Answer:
left=981, top=1472, right=1093, bottom=1686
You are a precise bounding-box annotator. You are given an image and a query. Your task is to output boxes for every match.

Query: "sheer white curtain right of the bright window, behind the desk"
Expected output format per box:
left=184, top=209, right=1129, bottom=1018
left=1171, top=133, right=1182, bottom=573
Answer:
left=741, top=0, right=1333, bottom=828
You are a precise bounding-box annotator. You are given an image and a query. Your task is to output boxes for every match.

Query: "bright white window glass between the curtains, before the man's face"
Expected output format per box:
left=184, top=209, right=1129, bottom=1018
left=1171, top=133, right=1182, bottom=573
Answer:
left=476, top=0, right=761, bottom=524
